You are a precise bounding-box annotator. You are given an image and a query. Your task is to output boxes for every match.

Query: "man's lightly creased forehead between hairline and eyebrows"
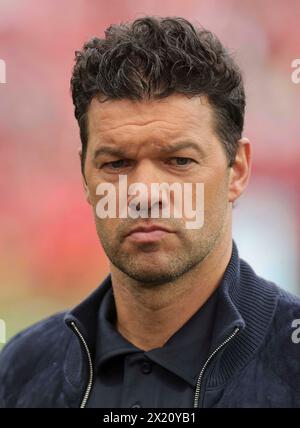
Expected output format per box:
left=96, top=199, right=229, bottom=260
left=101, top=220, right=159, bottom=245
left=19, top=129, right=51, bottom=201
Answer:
left=87, top=94, right=213, bottom=150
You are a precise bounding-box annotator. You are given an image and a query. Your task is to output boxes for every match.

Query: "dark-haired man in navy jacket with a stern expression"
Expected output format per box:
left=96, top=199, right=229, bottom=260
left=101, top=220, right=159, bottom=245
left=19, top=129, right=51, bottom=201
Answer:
left=0, top=17, right=300, bottom=408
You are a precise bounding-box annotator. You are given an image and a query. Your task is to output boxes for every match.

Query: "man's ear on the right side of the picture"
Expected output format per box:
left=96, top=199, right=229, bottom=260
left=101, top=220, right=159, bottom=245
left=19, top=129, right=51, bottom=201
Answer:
left=228, top=137, right=252, bottom=202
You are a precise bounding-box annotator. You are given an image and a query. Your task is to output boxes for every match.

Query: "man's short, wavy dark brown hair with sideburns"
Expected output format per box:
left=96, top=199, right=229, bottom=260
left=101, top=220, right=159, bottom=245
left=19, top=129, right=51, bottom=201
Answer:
left=71, top=16, right=246, bottom=172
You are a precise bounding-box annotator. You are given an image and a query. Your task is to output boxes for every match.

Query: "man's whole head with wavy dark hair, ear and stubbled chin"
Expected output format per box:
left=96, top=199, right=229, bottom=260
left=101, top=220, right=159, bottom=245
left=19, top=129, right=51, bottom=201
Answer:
left=71, top=17, right=250, bottom=284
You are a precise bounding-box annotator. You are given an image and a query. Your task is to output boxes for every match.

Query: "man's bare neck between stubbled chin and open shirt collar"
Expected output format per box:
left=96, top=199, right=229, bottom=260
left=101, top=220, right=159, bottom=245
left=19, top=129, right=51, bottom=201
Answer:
left=111, top=235, right=232, bottom=351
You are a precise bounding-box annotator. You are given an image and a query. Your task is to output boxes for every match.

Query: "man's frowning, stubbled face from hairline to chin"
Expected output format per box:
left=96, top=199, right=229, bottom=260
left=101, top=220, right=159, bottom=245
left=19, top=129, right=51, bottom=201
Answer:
left=85, top=94, right=234, bottom=285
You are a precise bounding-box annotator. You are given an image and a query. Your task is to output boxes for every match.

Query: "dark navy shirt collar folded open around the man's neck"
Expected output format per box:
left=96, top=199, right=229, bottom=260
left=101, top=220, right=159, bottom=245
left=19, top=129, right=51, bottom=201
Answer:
left=95, top=280, right=218, bottom=386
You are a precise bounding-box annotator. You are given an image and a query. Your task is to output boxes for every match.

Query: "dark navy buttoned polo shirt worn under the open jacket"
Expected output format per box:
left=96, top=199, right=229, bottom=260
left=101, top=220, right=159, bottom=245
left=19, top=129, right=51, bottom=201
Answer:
left=86, top=287, right=219, bottom=408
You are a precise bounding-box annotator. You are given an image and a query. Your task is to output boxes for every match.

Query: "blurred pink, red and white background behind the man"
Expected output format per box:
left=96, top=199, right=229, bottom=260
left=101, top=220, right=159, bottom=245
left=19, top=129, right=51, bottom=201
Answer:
left=0, top=0, right=300, bottom=347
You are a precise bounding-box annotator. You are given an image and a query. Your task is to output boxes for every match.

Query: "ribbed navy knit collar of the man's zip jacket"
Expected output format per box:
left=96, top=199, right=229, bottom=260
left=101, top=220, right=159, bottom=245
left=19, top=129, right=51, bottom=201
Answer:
left=64, top=241, right=278, bottom=388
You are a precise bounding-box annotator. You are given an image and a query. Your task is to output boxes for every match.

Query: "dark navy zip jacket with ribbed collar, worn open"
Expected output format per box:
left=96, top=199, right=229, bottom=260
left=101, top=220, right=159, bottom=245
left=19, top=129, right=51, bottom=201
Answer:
left=0, top=244, right=300, bottom=408
